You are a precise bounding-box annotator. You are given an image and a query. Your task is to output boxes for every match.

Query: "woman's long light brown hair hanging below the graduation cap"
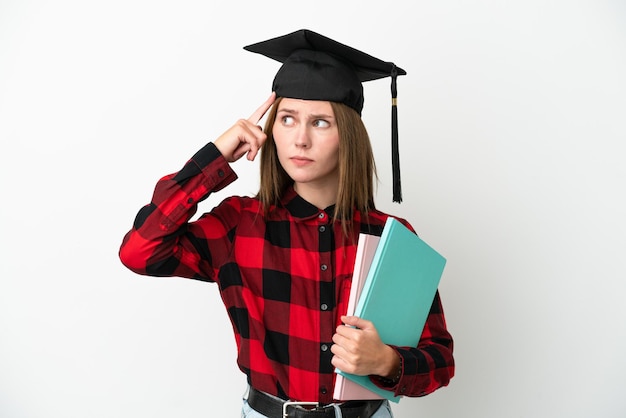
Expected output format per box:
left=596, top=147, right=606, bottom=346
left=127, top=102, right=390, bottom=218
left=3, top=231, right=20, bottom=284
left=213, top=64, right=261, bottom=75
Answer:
left=257, top=98, right=377, bottom=236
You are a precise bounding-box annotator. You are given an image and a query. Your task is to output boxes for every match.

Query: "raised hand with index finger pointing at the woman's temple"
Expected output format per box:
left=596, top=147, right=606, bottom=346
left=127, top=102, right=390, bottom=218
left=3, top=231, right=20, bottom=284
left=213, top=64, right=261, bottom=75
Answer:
left=213, top=93, right=276, bottom=163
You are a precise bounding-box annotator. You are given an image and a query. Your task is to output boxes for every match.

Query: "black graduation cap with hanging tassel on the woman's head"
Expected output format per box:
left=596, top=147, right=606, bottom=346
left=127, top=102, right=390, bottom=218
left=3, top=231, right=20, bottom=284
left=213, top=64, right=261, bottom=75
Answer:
left=244, top=29, right=406, bottom=203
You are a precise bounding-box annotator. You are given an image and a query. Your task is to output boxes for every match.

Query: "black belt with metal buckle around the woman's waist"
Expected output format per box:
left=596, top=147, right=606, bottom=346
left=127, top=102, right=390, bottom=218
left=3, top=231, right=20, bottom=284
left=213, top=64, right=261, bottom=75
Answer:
left=248, top=387, right=384, bottom=418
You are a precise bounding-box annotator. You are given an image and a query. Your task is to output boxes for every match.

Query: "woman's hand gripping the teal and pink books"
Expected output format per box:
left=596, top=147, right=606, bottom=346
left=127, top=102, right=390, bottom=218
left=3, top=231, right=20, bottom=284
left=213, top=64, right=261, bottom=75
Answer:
left=331, top=316, right=400, bottom=377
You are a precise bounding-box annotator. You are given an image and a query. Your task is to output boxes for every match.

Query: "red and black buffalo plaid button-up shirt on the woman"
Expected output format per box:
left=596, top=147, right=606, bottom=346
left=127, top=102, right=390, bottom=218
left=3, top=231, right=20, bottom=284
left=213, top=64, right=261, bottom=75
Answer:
left=120, top=143, right=454, bottom=403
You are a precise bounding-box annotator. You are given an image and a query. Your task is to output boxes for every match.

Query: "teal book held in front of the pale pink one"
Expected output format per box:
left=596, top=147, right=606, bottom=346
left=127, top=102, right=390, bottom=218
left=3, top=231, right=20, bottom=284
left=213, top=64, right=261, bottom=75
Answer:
left=335, top=217, right=446, bottom=402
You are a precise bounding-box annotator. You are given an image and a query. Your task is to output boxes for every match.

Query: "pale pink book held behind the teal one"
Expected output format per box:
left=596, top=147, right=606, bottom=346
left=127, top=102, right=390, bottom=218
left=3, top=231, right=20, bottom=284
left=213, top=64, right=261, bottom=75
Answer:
left=333, top=233, right=383, bottom=400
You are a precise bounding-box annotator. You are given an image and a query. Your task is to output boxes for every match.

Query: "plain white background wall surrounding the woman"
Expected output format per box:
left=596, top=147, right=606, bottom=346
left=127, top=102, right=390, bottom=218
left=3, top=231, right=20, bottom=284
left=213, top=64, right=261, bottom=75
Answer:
left=0, top=0, right=626, bottom=418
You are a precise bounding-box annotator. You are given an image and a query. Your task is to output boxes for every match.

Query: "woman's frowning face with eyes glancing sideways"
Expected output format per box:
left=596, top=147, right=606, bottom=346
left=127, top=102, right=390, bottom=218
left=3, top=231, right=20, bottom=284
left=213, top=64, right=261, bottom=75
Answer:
left=273, top=98, right=339, bottom=192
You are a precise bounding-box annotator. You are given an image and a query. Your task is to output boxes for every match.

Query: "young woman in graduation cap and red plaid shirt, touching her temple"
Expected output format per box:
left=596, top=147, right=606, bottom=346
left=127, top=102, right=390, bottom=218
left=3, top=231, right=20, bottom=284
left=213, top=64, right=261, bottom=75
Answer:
left=120, top=30, right=454, bottom=418
